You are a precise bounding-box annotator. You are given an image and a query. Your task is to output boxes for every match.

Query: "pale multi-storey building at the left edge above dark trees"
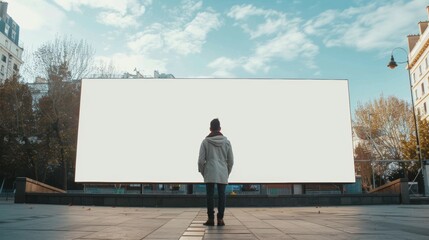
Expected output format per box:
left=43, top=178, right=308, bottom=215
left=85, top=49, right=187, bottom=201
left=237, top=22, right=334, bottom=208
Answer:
left=0, top=1, right=24, bottom=82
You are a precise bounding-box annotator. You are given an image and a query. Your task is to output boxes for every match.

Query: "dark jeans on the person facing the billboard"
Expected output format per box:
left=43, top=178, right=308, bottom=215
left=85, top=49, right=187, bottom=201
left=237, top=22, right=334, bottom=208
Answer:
left=206, top=183, right=226, bottom=219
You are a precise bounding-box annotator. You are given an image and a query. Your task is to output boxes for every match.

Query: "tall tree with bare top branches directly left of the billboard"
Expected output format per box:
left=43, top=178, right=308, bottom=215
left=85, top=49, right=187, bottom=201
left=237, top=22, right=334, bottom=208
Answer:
left=29, top=36, right=95, bottom=190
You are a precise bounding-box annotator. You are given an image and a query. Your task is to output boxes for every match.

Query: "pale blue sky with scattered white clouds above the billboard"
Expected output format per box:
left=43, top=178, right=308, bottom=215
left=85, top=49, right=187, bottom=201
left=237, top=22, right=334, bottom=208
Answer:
left=6, top=0, right=429, bottom=114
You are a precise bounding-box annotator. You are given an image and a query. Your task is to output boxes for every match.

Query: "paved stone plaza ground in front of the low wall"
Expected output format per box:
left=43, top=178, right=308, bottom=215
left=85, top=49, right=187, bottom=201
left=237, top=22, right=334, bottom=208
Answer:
left=0, top=201, right=429, bottom=240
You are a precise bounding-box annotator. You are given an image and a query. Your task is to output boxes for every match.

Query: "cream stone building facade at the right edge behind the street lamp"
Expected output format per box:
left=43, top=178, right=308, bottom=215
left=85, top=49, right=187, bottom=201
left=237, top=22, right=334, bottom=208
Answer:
left=408, top=6, right=429, bottom=121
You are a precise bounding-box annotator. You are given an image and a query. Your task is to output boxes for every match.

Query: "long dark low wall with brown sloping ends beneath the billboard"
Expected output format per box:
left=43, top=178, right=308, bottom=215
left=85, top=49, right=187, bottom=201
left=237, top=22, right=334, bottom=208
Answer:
left=15, top=177, right=410, bottom=207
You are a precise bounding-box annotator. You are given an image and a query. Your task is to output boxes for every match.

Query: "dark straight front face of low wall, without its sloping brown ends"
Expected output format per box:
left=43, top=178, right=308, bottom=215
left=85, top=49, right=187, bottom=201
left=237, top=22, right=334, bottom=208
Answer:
left=19, top=193, right=402, bottom=207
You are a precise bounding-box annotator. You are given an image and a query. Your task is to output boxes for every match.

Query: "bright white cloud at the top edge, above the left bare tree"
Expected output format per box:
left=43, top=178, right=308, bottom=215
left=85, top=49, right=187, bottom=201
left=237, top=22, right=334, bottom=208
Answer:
left=55, top=0, right=145, bottom=28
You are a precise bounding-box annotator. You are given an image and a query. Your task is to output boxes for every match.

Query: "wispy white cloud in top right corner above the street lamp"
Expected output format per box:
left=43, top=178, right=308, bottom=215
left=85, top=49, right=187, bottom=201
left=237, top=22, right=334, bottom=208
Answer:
left=306, top=0, right=427, bottom=51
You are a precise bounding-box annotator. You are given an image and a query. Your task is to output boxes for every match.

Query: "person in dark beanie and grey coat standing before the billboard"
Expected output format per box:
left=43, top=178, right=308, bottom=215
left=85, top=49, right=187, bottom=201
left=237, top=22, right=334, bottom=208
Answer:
left=198, top=118, right=234, bottom=226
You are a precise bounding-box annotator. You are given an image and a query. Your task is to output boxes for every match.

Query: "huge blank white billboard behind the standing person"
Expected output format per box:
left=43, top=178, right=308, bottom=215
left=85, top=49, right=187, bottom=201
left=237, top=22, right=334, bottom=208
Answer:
left=75, top=79, right=355, bottom=183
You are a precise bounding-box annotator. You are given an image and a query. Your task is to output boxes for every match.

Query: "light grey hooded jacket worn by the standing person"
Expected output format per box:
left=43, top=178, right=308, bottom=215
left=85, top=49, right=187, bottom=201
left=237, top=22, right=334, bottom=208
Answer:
left=198, top=135, right=234, bottom=184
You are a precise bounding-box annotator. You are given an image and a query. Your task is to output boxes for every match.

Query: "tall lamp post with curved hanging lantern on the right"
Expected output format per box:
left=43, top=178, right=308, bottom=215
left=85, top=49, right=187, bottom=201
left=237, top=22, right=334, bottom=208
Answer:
left=387, top=47, right=425, bottom=195
